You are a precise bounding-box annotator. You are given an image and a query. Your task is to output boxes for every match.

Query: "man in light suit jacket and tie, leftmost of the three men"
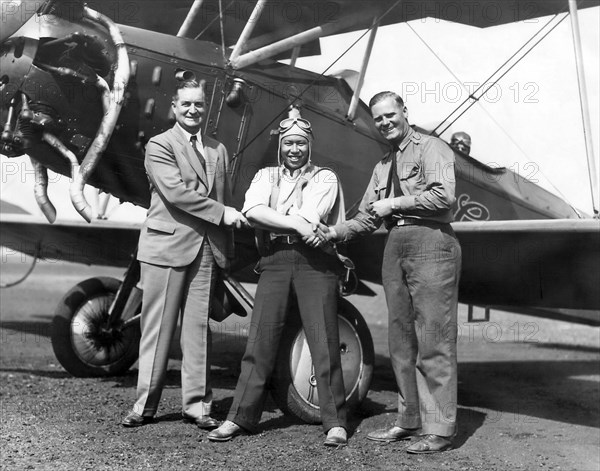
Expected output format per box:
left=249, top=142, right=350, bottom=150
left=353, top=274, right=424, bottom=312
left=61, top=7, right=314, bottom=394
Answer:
left=122, top=80, right=246, bottom=429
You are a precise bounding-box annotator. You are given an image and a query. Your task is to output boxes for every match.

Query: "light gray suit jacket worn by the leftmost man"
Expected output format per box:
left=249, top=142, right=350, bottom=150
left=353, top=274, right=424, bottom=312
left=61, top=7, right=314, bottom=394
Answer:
left=137, top=125, right=233, bottom=268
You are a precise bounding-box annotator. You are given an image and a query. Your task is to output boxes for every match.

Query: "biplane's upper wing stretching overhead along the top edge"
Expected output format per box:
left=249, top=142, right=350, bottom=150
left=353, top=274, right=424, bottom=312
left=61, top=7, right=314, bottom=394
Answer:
left=108, top=0, right=600, bottom=50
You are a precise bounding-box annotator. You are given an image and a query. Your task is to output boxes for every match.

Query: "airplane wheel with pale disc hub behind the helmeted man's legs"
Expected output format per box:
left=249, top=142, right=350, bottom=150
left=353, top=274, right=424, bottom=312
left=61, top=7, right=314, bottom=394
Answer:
left=271, top=299, right=375, bottom=424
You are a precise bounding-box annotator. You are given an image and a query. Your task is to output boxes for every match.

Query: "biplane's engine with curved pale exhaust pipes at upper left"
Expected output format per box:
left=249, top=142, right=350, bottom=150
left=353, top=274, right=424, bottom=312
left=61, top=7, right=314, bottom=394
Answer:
left=0, top=1, right=129, bottom=222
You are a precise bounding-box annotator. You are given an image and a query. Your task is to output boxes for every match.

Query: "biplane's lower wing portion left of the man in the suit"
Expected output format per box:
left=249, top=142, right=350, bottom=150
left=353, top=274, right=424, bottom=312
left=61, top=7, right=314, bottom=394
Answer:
left=0, top=213, right=141, bottom=267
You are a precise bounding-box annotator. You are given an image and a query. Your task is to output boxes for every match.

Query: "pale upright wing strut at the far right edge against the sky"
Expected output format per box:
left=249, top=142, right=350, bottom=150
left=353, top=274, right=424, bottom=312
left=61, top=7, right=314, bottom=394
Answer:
left=569, top=0, right=600, bottom=218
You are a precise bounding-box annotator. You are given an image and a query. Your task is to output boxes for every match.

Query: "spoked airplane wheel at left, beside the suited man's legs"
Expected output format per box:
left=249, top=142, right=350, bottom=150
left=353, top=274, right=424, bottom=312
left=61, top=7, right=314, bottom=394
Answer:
left=52, top=277, right=140, bottom=377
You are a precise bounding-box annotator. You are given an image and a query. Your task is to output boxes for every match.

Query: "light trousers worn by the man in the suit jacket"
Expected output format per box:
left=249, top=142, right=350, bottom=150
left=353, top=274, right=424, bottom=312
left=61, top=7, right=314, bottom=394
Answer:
left=133, top=241, right=216, bottom=417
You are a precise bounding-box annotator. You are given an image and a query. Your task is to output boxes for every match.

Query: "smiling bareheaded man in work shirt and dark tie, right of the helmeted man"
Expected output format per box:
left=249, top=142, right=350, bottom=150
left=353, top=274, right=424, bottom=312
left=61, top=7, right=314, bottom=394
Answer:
left=321, top=91, right=462, bottom=453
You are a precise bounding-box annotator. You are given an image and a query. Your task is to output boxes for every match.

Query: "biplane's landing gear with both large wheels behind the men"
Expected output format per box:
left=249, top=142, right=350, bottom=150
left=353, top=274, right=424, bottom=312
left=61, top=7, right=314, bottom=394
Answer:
left=52, top=270, right=375, bottom=423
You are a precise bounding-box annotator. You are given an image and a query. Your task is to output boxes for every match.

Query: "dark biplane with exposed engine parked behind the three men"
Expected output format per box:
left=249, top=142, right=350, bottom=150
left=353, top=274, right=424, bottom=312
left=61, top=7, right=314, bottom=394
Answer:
left=0, top=0, right=600, bottom=422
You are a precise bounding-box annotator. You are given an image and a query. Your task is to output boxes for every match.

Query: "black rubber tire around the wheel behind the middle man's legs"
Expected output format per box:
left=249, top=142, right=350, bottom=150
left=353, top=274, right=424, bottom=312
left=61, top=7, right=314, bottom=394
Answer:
left=271, top=298, right=375, bottom=424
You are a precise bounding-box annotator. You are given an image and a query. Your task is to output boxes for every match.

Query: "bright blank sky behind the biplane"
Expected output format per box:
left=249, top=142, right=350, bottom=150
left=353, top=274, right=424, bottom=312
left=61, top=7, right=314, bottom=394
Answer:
left=0, top=8, right=600, bottom=220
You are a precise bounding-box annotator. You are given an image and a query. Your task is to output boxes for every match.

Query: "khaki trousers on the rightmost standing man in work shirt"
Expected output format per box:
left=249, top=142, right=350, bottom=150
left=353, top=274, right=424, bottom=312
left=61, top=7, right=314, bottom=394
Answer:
left=382, top=224, right=461, bottom=436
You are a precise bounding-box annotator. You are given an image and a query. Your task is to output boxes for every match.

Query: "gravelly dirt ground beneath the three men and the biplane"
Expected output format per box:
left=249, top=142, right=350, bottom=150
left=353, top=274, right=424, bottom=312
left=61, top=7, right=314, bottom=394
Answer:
left=0, top=255, right=600, bottom=471
